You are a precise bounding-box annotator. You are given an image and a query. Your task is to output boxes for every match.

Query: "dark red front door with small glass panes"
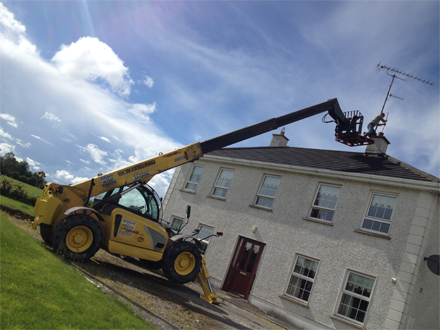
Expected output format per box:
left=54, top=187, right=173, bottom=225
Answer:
left=223, top=237, right=265, bottom=299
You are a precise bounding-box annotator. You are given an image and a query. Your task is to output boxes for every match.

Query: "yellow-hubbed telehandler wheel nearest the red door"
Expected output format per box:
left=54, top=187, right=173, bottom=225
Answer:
left=162, top=241, right=202, bottom=284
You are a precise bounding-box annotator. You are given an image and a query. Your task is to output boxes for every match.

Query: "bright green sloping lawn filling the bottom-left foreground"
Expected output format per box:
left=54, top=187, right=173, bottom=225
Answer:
left=0, top=215, right=153, bottom=329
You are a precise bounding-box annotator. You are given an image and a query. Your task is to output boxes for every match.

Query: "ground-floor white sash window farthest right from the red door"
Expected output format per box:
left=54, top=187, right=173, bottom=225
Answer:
left=337, top=271, right=374, bottom=323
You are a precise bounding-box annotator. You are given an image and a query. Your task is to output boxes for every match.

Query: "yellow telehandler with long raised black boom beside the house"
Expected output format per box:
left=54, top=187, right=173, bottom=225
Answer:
left=32, top=99, right=371, bottom=302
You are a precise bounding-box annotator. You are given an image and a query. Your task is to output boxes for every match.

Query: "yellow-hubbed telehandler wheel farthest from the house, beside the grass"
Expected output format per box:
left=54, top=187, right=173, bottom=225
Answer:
left=53, top=214, right=102, bottom=261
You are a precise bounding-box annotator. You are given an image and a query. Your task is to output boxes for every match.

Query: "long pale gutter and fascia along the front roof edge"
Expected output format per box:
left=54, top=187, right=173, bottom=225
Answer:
left=202, top=155, right=440, bottom=194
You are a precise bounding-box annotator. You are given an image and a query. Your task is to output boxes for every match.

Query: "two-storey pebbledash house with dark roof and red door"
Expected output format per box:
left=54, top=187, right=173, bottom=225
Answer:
left=163, top=134, right=440, bottom=329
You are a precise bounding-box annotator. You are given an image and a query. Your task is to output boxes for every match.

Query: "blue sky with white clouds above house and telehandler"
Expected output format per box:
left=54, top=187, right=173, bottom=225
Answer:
left=0, top=0, right=440, bottom=197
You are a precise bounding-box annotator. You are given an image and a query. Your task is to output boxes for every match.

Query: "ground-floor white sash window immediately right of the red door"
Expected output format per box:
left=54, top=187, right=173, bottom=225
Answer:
left=286, top=256, right=319, bottom=302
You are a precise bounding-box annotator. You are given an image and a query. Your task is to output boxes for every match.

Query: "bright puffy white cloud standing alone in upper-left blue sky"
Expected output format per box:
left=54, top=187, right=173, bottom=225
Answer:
left=52, top=37, right=133, bottom=96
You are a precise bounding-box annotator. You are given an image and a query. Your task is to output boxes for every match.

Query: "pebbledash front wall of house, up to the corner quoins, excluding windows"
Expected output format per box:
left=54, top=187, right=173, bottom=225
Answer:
left=164, top=159, right=438, bottom=329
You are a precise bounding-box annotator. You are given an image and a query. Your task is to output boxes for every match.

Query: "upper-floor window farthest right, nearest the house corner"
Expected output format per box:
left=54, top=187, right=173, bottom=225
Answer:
left=362, top=194, right=396, bottom=234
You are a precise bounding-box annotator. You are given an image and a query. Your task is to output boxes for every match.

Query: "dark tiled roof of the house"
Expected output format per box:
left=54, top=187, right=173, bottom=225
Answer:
left=207, top=147, right=440, bottom=183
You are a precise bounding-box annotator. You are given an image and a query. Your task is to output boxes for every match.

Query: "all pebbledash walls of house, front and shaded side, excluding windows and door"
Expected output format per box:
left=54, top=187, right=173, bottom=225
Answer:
left=163, top=149, right=440, bottom=329
